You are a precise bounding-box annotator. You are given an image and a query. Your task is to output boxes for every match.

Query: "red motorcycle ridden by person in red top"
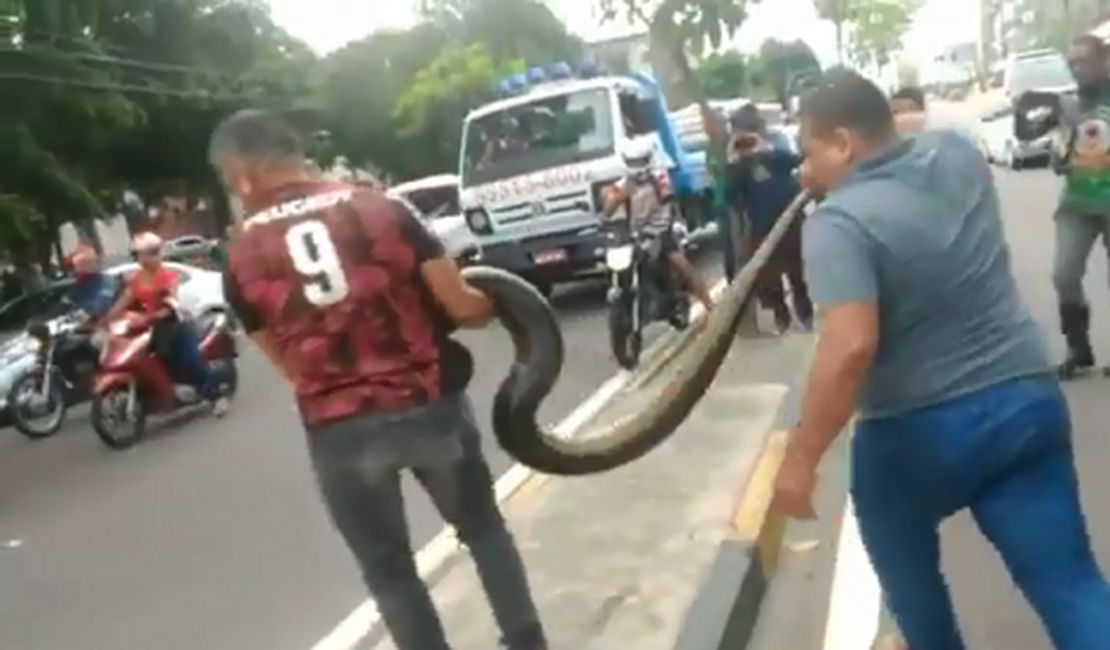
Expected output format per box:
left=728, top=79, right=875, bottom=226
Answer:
left=91, top=306, right=239, bottom=449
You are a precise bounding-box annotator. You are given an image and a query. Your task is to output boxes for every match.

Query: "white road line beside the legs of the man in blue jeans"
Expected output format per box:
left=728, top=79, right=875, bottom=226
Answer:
left=823, top=498, right=882, bottom=650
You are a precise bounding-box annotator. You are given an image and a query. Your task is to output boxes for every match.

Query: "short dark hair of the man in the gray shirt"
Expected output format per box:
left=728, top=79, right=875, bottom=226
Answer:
left=798, top=71, right=895, bottom=140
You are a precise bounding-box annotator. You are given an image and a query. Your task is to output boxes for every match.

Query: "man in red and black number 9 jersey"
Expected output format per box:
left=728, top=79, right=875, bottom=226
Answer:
left=210, top=111, right=547, bottom=650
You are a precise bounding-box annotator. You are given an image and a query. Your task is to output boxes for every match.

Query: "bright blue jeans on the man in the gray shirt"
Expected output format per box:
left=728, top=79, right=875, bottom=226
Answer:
left=851, top=378, right=1110, bottom=650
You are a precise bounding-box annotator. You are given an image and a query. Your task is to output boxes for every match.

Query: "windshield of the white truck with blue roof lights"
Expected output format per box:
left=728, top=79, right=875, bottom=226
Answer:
left=462, top=89, right=614, bottom=186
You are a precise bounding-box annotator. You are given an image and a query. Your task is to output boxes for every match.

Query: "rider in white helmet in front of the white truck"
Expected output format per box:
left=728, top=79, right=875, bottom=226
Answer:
left=602, top=140, right=713, bottom=312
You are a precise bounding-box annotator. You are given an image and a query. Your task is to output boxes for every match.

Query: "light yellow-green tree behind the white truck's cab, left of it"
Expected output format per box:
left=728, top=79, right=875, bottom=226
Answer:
left=320, top=0, right=583, bottom=177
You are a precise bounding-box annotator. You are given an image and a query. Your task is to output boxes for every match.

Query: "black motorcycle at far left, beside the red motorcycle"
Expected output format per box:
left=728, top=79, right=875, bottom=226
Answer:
left=8, top=314, right=100, bottom=440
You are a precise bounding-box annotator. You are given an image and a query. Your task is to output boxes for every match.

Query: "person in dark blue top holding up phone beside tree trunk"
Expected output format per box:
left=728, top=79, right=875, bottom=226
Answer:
left=725, top=104, right=814, bottom=332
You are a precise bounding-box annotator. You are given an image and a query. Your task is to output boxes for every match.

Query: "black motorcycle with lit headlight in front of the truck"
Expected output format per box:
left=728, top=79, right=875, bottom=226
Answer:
left=605, top=220, right=690, bottom=370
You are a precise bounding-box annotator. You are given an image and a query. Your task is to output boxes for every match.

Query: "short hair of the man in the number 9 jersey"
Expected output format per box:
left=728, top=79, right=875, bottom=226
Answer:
left=209, top=109, right=304, bottom=163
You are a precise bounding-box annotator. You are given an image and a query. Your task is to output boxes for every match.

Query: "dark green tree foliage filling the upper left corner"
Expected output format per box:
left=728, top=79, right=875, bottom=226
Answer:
left=0, top=0, right=314, bottom=248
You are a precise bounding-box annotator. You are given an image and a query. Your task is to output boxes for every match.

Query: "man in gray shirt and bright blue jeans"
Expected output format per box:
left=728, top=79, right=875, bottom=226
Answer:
left=775, top=74, right=1110, bottom=650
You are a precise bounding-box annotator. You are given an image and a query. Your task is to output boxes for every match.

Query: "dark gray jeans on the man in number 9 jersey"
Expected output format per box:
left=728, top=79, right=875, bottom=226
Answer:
left=309, top=396, right=546, bottom=650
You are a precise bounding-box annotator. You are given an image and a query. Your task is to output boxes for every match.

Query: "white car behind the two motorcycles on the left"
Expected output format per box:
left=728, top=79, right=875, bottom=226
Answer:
left=0, top=262, right=228, bottom=425
